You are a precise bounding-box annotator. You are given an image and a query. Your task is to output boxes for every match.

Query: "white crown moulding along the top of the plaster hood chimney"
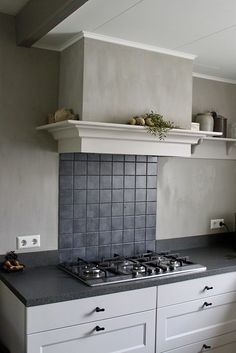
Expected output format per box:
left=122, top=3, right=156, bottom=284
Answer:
left=35, top=31, right=196, bottom=60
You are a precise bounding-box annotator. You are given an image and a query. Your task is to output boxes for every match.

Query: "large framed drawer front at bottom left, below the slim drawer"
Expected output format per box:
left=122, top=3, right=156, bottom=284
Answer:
left=27, top=310, right=155, bottom=353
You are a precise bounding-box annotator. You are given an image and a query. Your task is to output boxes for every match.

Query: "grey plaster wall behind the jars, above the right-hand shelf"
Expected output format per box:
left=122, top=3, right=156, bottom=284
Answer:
left=193, top=77, right=236, bottom=136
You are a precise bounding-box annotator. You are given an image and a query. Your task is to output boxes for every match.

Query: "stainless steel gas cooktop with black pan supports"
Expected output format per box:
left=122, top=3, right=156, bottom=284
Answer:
left=59, top=251, right=206, bottom=286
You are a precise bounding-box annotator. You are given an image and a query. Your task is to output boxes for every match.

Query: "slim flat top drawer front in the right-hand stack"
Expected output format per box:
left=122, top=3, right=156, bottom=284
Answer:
left=157, top=272, right=236, bottom=307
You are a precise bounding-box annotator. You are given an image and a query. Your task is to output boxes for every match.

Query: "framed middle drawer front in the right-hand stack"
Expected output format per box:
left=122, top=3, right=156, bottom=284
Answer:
left=157, top=292, right=236, bottom=352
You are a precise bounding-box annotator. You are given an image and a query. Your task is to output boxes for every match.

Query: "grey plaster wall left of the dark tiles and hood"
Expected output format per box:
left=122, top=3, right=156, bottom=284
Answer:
left=0, top=14, right=59, bottom=254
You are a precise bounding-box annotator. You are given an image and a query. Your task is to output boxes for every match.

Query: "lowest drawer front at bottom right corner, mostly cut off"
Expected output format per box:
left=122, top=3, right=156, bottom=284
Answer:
left=162, top=332, right=236, bottom=353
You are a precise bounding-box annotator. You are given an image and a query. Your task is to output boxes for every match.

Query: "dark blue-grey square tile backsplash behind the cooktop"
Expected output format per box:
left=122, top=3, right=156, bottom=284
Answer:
left=59, top=153, right=157, bottom=261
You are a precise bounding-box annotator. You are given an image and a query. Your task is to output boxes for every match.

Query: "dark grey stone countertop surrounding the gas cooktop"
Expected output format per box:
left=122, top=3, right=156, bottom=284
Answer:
left=0, top=246, right=236, bottom=307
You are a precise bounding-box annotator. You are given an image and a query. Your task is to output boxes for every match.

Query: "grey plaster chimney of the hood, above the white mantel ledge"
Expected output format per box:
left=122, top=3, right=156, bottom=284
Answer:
left=59, top=38, right=192, bottom=128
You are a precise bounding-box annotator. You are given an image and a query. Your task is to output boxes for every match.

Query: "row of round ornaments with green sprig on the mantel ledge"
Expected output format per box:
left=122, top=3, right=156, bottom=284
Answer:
left=128, top=110, right=175, bottom=140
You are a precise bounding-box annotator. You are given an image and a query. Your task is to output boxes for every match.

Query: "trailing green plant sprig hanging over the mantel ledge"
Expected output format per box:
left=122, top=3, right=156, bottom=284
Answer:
left=145, top=111, right=175, bottom=140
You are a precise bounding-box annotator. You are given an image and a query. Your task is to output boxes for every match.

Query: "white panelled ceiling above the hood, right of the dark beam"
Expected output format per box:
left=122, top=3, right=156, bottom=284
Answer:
left=28, top=0, right=236, bottom=80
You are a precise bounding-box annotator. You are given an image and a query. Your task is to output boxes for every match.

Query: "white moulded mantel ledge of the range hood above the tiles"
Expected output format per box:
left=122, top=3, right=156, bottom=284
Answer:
left=37, top=120, right=222, bottom=157
